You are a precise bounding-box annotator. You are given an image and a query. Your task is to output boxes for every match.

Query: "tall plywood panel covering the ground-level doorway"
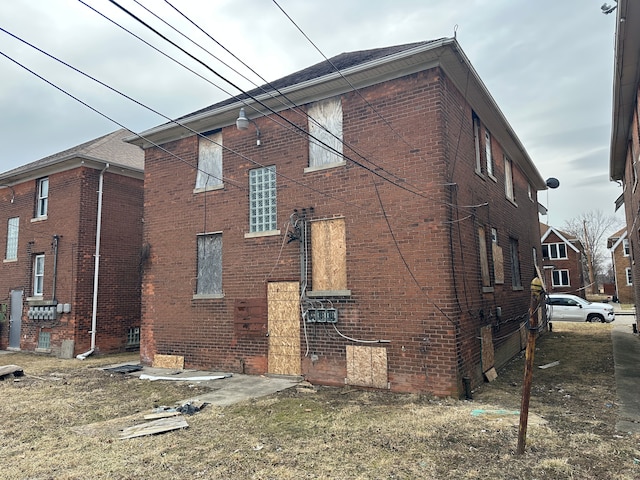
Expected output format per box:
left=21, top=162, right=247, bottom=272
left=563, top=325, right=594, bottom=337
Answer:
left=267, top=282, right=301, bottom=375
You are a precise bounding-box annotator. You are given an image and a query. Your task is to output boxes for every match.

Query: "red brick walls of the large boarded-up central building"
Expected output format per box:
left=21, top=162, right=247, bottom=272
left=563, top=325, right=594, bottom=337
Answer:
left=141, top=70, right=540, bottom=395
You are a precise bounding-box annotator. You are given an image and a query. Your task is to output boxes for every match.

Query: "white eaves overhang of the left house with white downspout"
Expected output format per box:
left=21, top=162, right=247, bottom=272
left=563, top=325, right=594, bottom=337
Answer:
left=0, top=154, right=144, bottom=186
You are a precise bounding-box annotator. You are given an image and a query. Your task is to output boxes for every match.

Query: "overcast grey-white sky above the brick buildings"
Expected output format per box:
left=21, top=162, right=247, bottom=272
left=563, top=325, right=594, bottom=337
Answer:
left=0, top=0, right=623, bottom=227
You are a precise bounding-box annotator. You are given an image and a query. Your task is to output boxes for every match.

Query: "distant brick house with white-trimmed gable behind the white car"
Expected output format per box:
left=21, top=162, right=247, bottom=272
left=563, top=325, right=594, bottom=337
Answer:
left=540, top=223, right=586, bottom=298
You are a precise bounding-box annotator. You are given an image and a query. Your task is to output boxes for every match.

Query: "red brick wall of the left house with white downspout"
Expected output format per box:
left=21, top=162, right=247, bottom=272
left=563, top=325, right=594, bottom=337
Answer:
left=0, top=167, right=142, bottom=354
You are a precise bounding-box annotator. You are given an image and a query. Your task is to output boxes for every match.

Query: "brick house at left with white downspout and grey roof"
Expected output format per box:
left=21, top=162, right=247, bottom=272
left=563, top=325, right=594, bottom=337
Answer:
left=0, top=130, right=144, bottom=358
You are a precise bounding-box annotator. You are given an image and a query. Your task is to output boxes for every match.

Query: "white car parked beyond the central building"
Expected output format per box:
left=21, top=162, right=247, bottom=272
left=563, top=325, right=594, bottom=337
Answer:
left=547, top=293, right=616, bottom=323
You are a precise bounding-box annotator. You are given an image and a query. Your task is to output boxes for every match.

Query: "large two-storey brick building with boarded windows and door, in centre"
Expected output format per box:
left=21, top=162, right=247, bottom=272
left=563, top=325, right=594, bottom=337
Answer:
left=129, top=39, right=546, bottom=396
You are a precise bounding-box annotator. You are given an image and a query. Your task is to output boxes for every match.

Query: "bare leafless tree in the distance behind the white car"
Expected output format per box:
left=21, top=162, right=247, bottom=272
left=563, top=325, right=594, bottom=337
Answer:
left=564, top=210, right=620, bottom=293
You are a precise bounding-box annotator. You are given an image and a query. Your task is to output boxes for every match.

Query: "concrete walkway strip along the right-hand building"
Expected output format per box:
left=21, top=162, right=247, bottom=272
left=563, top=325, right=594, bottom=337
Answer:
left=611, top=325, right=640, bottom=434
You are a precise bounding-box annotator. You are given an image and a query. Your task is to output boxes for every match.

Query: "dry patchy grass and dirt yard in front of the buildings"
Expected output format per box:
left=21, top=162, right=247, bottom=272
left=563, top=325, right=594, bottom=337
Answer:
left=0, top=323, right=640, bottom=480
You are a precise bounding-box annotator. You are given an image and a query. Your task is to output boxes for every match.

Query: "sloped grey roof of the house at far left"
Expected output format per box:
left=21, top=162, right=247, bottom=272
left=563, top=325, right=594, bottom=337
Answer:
left=0, top=128, right=144, bottom=183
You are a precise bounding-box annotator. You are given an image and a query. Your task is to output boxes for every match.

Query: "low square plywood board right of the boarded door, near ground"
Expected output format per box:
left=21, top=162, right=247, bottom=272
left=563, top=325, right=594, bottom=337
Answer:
left=346, top=345, right=389, bottom=388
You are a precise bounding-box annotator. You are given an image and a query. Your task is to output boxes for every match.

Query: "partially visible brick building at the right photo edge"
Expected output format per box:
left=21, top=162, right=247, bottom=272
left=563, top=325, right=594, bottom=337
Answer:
left=609, top=0, right=640, bottom=310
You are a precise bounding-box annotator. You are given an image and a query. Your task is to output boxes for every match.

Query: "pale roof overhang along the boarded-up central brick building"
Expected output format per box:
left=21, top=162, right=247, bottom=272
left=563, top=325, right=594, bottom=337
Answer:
left=125, top=38, right=547, bottom=190
